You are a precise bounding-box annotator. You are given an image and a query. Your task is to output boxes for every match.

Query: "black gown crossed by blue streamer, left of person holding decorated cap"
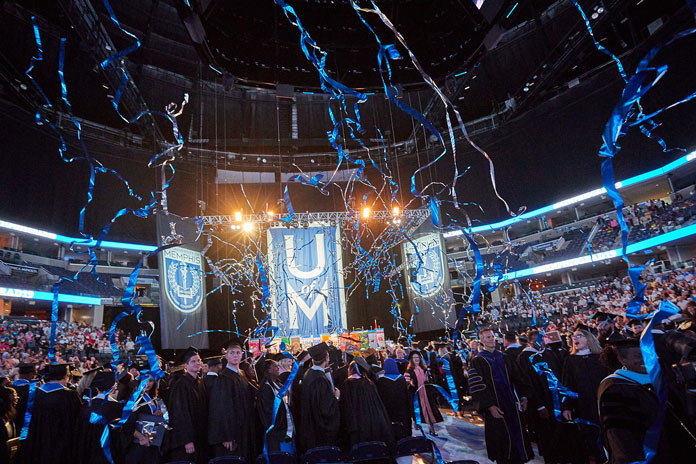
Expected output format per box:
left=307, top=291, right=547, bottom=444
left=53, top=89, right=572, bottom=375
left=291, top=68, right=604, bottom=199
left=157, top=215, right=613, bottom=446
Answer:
left=75, top=397, right=124, bottom=464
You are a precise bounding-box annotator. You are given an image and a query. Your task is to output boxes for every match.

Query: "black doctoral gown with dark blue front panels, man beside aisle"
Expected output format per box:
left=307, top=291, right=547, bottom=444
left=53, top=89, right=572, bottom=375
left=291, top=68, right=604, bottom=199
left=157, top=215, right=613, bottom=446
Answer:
left=469, top=350, right=534, bottom=462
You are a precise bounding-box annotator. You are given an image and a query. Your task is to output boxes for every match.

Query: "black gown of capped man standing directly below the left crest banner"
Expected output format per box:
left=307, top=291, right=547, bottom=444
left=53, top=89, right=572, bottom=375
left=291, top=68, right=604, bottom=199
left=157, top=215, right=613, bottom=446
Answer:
left=165, top=373, right=207, bottom=454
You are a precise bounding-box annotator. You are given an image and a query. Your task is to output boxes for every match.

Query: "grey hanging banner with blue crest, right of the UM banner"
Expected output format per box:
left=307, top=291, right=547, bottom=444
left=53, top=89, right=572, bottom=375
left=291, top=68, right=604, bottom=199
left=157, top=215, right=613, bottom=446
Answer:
left=402, top=232, right=456, bottom=333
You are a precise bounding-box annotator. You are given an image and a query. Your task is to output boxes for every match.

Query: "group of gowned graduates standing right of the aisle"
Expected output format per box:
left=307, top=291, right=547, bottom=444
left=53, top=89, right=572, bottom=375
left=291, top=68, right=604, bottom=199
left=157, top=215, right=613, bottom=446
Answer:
left=467, top=313, right=696, bottom=464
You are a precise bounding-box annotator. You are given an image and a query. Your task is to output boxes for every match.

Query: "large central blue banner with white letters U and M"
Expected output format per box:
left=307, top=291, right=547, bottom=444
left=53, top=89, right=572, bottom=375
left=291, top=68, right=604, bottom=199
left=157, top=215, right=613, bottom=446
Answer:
left=268, top=223, right=346, bottom=337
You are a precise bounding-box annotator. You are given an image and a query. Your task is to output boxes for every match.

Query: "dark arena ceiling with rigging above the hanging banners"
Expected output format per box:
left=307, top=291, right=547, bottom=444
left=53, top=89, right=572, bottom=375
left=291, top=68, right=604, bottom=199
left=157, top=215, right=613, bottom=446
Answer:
left=0, top=0, right=689, bottom=175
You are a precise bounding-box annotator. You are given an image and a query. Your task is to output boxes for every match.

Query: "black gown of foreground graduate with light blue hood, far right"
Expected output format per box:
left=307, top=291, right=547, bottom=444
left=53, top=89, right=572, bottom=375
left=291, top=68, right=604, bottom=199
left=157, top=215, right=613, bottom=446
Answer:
left=598, top=371, right=696, bottom=464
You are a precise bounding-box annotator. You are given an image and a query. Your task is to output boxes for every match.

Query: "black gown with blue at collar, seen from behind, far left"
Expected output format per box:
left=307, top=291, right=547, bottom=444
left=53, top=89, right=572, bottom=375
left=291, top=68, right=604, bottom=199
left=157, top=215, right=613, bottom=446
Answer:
left=21, top=382, right=81, bottom=464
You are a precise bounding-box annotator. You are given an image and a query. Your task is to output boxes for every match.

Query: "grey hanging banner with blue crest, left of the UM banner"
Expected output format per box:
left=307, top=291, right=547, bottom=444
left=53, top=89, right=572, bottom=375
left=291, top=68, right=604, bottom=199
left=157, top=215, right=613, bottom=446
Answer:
left=156, top=212, right=208, bottom=349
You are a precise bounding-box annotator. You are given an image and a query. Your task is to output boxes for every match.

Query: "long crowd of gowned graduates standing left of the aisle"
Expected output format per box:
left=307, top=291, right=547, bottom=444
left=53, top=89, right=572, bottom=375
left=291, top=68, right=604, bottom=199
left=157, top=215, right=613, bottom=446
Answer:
left=0, top=340, right=456, bottom=464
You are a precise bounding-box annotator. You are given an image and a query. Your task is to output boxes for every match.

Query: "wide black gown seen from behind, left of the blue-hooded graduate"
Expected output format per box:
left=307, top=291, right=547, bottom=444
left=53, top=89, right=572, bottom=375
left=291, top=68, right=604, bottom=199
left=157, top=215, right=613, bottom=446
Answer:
left=340, top=377, right=394, bottom=449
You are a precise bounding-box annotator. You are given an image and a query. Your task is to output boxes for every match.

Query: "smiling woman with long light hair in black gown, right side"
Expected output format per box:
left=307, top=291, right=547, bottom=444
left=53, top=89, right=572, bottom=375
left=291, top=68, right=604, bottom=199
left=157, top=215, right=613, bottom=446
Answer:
left=561, top=327, right=611, bottom=463
